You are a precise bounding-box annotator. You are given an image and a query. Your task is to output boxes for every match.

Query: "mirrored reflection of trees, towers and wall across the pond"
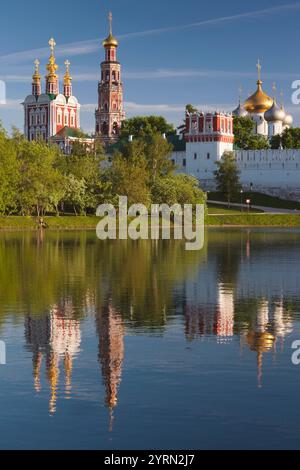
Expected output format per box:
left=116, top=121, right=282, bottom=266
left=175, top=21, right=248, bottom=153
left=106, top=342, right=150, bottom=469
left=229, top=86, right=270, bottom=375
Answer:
left=0, top=230, right=300, bottom=422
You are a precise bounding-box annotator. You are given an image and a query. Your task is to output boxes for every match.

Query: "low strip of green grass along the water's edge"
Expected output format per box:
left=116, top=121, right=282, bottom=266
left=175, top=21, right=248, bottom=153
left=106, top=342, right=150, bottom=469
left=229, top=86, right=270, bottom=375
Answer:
left=0, top=211, right=300, bottom=231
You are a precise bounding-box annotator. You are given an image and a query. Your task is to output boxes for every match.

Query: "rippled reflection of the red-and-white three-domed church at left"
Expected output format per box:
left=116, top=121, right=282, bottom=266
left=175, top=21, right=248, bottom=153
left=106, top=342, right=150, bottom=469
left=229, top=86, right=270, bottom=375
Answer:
left=25, top=302, right=81, bottom=414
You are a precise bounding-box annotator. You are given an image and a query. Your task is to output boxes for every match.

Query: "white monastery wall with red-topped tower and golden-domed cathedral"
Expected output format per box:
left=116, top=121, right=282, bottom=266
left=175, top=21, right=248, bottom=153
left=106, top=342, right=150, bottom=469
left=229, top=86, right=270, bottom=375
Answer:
left=171, top=62, right=300, bottom=200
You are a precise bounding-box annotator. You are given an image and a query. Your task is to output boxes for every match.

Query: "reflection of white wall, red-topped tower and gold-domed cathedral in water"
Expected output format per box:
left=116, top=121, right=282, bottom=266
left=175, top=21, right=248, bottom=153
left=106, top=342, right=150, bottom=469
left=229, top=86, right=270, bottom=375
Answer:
left=183, top=234, right=300, bottom=386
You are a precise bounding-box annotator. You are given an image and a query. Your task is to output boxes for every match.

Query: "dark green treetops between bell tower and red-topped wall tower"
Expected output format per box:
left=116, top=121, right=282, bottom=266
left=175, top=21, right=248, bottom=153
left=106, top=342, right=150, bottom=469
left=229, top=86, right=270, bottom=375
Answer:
left=120, top=116, right=176, bottom=140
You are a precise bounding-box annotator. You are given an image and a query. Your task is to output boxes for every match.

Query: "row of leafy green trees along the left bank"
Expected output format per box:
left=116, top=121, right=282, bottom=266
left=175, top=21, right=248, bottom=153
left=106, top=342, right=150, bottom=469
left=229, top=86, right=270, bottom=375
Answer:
left=0, top=122, right=205, bottom=216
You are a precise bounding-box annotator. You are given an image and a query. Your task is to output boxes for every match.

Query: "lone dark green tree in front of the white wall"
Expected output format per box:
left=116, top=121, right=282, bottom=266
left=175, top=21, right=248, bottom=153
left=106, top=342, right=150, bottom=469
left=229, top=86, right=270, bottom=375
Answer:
left=215, top=152, right=241, bottom=206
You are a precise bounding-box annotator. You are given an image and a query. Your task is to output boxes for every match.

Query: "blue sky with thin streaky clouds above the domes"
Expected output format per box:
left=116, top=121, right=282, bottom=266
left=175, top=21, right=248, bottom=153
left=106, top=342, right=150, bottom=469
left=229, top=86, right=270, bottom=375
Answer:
left=0, top=0, right=300, bottom=131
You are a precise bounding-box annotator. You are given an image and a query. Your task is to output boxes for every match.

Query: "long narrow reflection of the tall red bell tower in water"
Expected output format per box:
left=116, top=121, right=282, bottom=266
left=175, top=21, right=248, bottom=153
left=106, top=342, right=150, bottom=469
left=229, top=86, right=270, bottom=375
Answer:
left=96, top=303, right=124, bottom=430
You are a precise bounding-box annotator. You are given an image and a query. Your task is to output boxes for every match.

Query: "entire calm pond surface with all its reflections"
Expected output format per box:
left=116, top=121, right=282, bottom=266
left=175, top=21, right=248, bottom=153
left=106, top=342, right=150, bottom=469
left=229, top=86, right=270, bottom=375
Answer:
left=0, top=229, right=300, bottom=449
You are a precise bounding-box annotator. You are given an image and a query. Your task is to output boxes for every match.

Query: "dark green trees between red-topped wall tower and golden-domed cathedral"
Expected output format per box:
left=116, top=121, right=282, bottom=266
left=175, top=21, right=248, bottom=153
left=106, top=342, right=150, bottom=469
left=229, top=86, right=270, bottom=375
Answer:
left=233, top=116, right=270, bottom=150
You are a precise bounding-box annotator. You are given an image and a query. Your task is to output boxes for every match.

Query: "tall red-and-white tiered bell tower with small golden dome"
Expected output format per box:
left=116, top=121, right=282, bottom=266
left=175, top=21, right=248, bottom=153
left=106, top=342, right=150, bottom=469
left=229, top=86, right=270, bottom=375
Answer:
left=96, top=13, right=125, bottom=144
